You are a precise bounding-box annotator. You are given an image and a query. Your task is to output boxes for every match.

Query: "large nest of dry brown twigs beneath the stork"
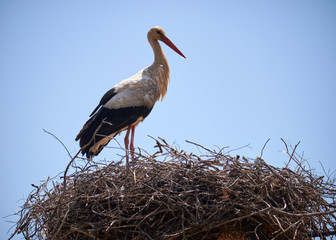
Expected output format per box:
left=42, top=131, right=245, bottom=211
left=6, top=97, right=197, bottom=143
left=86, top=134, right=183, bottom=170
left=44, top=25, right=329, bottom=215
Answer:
left=12, top=139, right=336, bottom=240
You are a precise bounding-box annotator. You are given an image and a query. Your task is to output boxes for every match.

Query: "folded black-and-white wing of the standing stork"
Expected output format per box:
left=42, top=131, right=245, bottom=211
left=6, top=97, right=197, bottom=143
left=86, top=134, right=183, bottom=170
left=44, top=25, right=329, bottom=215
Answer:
left=76, top=86, right=159, bottom=156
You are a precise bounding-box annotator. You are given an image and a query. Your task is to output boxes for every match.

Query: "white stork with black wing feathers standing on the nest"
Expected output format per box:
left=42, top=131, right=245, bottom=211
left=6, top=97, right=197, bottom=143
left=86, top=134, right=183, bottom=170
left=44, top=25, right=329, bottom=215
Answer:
left=75, top=26, right=186, bottom=166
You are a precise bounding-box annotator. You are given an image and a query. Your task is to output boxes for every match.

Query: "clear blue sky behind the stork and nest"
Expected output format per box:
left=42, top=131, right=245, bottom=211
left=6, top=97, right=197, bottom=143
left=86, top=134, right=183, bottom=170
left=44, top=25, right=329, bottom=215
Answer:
left=0, top=0, right=336, bottom=239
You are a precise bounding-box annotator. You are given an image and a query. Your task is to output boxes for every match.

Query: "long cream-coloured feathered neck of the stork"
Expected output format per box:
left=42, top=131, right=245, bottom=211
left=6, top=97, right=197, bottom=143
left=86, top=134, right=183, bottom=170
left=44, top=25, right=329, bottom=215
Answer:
left=149, top=40, right=169, bottom=100
